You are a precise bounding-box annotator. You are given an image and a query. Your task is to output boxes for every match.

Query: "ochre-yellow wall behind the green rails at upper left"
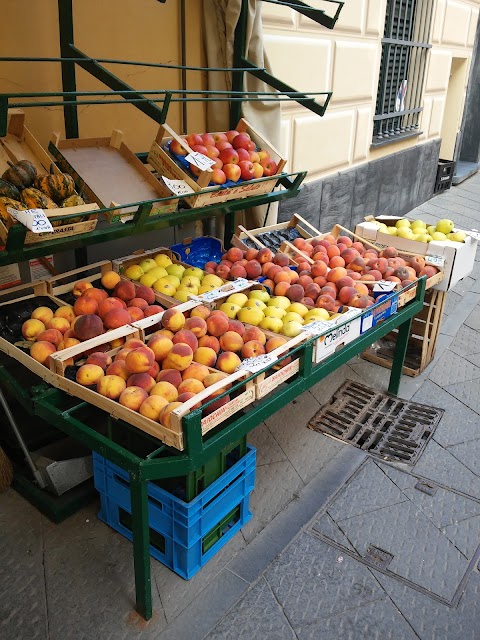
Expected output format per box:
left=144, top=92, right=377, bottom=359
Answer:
left=0, top=0, right=205, bottom=151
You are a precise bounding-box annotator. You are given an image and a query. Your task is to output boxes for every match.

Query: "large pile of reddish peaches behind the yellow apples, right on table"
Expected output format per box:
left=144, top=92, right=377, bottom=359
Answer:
left=205, top=234, right=438, bottom=312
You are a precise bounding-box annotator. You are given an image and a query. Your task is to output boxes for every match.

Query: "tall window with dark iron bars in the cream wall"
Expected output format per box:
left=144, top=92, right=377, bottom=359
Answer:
left=372, top=0, right=434, bottom=146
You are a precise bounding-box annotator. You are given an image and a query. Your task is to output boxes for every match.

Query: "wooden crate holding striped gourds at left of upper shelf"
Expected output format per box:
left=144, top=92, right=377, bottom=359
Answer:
left=0, top=109, right=98, bottom=244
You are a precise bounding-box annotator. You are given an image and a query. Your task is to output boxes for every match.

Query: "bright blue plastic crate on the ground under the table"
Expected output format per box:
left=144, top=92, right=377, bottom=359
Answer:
left=93, top=446, right=256, bottom=580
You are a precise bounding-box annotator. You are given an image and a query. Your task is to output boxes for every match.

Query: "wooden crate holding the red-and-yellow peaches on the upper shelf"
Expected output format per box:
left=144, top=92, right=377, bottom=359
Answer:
left=148, top=118, right=287, bottom=208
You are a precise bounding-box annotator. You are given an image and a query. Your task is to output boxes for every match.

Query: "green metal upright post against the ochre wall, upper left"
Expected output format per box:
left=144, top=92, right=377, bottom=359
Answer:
left=58, top=0, right=79, bottom=139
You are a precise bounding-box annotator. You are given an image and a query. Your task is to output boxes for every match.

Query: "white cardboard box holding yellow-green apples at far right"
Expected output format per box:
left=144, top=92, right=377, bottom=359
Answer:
left=355, top=216, right=477, bottom=291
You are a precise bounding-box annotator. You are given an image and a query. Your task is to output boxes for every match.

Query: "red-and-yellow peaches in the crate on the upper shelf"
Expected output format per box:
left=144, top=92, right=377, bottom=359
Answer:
left=170, top=130, right=277, bottom=184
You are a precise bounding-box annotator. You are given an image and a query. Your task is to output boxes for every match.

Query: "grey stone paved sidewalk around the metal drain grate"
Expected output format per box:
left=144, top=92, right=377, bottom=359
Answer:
left=0, top=175, right=480, bottom=640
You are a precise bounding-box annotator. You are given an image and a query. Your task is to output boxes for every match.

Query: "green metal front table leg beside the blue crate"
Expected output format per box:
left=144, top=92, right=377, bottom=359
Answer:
left=130, top=473, right=152, bottom=620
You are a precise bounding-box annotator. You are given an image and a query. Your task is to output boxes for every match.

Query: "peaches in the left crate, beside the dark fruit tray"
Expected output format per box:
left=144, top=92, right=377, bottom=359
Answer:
left=22, top=271, right=163, bottom=365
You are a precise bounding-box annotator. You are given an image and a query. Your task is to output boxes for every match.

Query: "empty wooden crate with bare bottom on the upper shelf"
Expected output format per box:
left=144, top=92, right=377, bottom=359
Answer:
left=48, top=130, right=178, bottom=222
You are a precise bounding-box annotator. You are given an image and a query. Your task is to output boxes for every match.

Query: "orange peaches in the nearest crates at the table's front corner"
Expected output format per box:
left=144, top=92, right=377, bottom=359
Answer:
left=72, top=305, right=287, bottom=427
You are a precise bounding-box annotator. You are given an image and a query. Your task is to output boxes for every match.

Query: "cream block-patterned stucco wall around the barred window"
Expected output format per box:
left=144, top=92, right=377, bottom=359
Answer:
left=263, top=0, right=480, bottom=180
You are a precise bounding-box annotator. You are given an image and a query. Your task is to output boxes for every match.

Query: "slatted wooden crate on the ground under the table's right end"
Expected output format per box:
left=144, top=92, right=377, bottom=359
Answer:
left=362, top=289, right=447, bottom=377
